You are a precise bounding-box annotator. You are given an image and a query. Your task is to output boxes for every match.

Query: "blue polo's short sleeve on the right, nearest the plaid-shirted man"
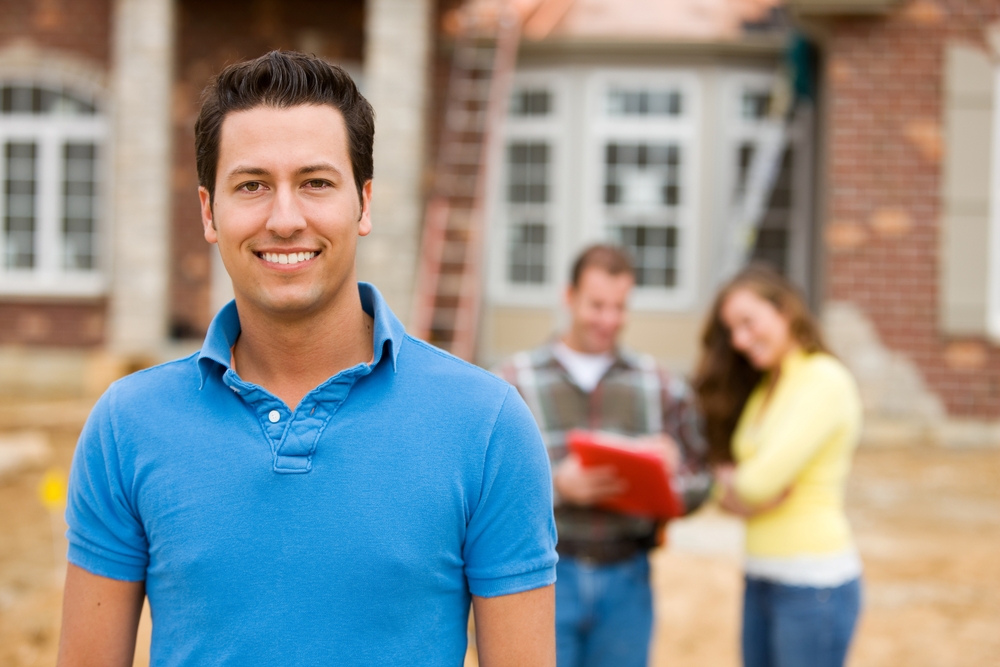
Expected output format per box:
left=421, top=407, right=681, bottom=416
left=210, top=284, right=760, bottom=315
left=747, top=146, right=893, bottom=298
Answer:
left=463, top=389, right=558, bottom=597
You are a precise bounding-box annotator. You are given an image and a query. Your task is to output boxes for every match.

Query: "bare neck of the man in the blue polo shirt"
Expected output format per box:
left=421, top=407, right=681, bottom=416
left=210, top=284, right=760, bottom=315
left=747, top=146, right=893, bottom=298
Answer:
left=233, top=281, right=374, bottom=407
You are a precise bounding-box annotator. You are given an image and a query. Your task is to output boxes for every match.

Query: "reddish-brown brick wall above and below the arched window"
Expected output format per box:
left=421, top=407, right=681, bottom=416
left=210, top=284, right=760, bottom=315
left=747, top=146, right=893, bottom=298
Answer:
left=0, top=0, right=111, bottom=347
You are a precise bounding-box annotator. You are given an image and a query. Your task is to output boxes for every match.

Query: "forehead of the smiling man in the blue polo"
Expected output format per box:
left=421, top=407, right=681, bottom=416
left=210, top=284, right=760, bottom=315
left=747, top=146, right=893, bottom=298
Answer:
left=219, top=104, right=350, bottom=178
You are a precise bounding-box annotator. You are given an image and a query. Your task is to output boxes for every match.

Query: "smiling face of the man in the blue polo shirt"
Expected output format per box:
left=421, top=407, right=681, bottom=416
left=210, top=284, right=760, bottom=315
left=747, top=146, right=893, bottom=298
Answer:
left=198, top=105, right=371, bottom=317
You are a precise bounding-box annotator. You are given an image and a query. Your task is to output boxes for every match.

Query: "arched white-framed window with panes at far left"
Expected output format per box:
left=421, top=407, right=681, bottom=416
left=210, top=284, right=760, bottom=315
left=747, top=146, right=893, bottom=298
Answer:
left=0, top=81, right=107, bottom=296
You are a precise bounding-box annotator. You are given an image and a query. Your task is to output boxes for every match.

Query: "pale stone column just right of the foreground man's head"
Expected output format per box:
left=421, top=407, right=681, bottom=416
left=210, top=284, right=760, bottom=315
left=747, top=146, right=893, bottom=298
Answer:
left=358, top=0, right=433, bottom=324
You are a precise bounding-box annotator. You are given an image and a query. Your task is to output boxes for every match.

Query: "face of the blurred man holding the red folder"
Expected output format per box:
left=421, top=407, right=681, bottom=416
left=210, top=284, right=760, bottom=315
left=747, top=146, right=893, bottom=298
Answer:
left=566, top=268, right=634, bottom=354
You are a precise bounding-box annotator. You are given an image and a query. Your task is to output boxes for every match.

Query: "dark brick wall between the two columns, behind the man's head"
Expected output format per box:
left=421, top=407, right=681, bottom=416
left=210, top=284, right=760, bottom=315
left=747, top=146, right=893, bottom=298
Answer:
left=170, top=0, right=364, bottom=338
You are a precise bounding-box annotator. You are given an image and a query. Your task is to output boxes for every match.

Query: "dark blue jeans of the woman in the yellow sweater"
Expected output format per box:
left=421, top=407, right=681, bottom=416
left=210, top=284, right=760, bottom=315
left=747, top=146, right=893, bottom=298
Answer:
left=743, top=577, right=861, bottom=667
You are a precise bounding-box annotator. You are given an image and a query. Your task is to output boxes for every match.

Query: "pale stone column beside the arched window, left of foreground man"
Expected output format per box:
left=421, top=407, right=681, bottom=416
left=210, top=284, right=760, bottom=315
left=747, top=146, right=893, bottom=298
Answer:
left=109, top=0, right=174, bottom=354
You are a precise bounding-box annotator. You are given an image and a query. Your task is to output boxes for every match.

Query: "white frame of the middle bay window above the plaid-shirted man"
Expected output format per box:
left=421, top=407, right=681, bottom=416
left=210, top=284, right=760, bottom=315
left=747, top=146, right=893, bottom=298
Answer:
left=583, top=67, right=702, bottom=311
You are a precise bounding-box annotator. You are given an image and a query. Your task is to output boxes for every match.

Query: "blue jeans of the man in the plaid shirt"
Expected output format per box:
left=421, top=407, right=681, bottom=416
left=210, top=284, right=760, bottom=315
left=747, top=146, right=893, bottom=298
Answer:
left=556, top=552, right=653, bottom=667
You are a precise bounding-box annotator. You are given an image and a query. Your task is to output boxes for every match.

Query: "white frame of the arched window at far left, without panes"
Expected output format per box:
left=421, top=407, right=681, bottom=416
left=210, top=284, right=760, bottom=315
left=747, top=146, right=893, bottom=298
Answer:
left=0, top=85, right=109, bottom=297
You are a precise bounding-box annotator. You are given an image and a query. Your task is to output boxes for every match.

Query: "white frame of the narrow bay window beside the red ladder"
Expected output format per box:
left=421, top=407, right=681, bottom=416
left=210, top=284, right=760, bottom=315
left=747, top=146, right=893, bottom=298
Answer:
left=486, top=69, right=572, bottom=307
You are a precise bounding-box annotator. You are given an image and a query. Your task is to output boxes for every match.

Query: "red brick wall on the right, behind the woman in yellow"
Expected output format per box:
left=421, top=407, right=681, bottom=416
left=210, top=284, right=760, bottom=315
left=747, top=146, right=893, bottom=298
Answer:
left=825, top=0, right=1000, bottom=418
